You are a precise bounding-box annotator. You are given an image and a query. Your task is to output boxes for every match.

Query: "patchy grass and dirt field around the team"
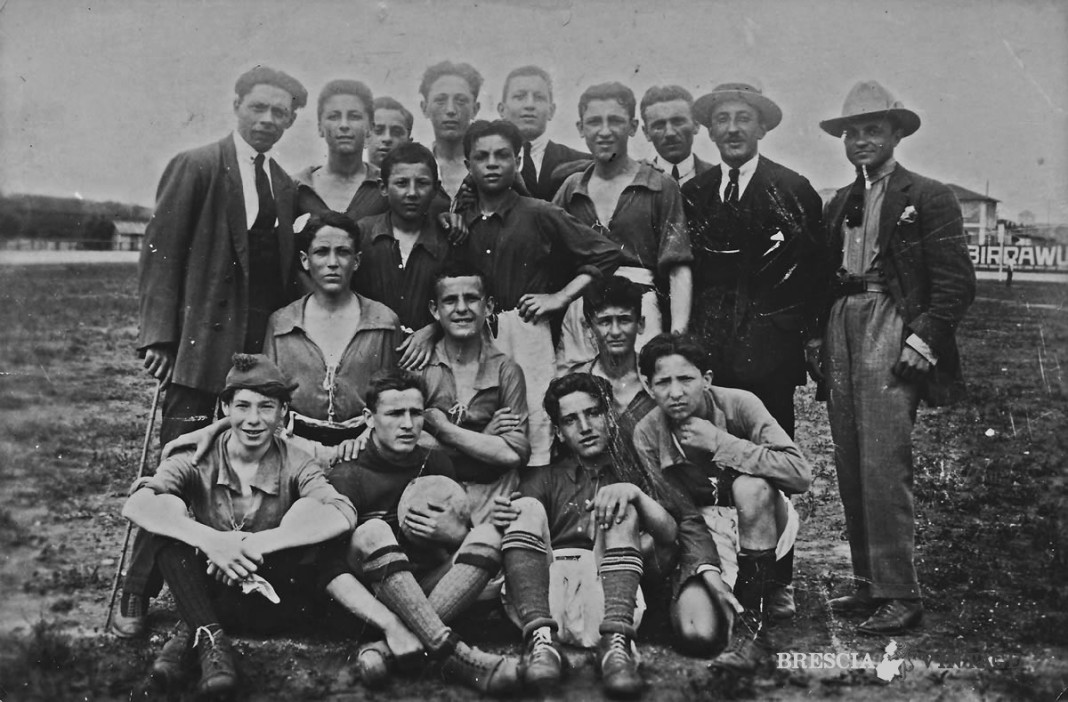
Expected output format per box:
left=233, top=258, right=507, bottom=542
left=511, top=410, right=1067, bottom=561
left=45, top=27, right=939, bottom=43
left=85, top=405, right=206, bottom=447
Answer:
left=0, top=264, right=1068, bottom=702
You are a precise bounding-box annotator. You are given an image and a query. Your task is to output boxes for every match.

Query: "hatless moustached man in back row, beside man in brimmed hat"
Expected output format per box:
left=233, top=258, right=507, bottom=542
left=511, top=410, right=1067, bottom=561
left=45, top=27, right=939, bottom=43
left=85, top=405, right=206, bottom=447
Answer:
left=641, top=85, right=713, bottom=187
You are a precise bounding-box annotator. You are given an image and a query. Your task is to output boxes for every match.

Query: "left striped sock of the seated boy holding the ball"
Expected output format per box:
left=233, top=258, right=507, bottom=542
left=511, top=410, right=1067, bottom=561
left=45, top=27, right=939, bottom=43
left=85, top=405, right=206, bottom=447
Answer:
left=363, top=544, right=452, bottom=653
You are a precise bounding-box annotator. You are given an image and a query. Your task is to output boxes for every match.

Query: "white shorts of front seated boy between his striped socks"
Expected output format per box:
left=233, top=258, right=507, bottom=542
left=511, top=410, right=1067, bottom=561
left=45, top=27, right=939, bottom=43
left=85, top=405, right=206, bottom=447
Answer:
left=501, top=548, right=646, bottom=649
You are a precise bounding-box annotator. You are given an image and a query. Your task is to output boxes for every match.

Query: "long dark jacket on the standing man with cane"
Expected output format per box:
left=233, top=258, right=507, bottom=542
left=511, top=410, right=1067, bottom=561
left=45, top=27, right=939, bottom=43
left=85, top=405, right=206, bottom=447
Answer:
left=138, top=136, right=296, bottom=392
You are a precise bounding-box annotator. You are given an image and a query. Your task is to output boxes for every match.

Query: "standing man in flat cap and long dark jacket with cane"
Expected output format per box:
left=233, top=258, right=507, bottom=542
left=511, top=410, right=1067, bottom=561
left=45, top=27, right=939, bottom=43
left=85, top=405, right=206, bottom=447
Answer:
left=119, top=66, right=308, bottom=636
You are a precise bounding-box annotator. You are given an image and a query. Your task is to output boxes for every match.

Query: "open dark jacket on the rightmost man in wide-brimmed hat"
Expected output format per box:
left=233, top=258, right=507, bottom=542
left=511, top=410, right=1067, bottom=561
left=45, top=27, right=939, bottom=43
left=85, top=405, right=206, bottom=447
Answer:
left=824, top=166, right=975, bottom=405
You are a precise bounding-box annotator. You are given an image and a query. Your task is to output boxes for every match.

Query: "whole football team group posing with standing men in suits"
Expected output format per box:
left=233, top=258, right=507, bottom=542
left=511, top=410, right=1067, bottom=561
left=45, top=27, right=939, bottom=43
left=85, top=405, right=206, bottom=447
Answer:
left=119, top=61, right=974, bottom=697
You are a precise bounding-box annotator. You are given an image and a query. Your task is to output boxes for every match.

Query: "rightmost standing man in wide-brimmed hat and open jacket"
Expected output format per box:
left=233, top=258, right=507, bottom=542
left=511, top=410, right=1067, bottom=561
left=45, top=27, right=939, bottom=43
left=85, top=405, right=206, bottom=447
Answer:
left=807, top=81, right=975, bottom=635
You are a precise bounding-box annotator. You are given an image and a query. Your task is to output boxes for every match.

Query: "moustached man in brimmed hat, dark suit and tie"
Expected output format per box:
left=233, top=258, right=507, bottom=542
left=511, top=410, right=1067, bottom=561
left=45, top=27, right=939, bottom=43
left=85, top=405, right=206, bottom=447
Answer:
left=682, top=83, right=828, bottom=617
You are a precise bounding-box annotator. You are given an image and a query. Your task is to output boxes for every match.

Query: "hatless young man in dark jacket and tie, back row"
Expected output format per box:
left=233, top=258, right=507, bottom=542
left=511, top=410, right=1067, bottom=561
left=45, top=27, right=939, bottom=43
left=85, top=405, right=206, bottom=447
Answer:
left=497, top=66, right=592, bottom=202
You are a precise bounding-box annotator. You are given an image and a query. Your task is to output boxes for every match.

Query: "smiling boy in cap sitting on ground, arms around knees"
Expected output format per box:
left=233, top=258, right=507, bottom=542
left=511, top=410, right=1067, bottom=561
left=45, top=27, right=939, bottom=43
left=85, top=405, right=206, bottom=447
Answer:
left=123, top=354, right=356, bottom=696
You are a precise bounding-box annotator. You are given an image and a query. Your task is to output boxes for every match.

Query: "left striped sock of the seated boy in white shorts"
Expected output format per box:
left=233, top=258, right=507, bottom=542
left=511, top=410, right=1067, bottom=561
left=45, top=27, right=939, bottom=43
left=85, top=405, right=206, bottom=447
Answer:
left=501, top=530, right=556, bottom=637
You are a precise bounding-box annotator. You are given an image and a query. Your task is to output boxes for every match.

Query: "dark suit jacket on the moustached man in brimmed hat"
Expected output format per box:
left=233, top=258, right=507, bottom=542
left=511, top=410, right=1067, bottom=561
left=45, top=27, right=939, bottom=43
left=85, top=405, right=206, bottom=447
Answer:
left=682, top=156, right=828, bottom=385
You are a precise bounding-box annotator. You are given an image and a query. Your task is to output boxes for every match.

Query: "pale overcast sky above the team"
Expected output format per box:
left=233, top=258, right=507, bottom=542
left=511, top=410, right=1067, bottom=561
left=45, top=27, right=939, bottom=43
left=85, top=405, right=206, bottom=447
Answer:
left=0, top=0, right=1068, bottom=221
